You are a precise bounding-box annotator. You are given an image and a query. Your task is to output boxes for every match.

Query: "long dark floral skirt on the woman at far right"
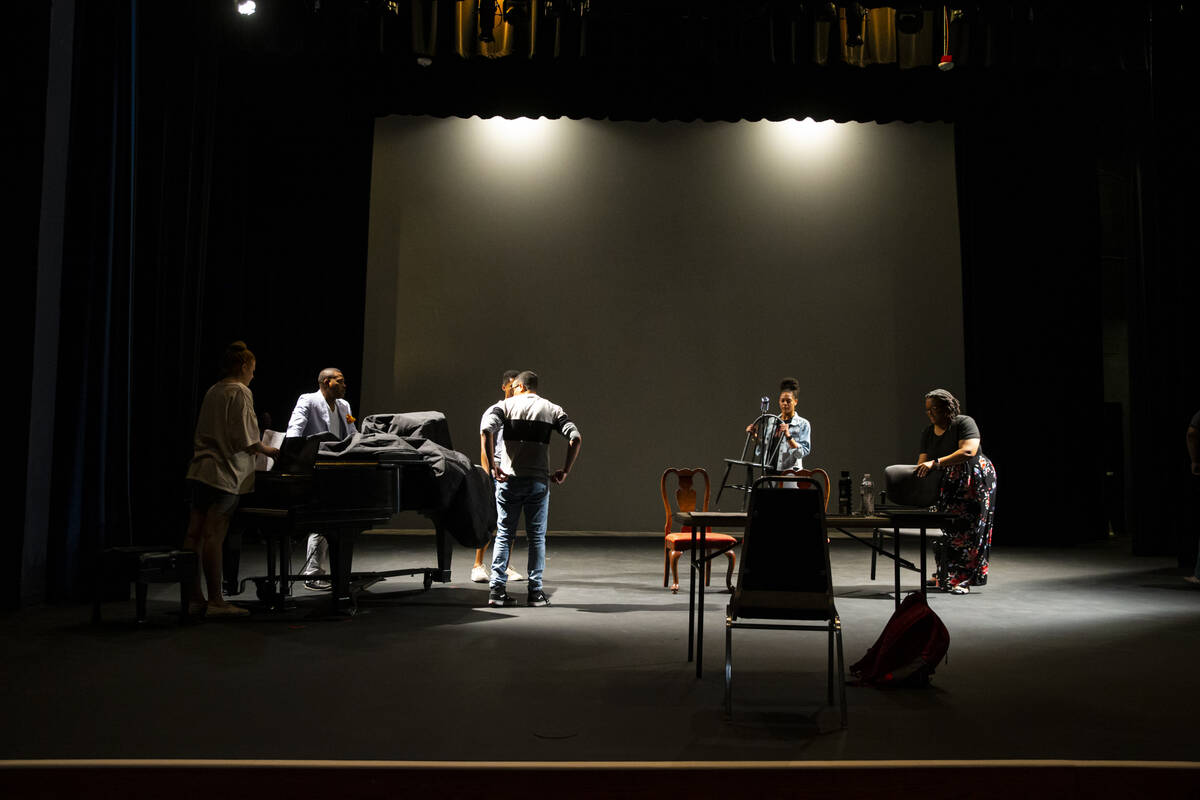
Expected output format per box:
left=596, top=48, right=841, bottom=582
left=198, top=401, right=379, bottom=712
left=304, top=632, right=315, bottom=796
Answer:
left=935, top=456, right=996, bottom=589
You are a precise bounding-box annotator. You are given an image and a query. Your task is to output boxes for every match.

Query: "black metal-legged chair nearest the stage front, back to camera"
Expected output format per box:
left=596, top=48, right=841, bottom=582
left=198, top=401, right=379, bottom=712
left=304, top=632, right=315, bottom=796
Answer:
left=725, top=475, right=846, bottom=728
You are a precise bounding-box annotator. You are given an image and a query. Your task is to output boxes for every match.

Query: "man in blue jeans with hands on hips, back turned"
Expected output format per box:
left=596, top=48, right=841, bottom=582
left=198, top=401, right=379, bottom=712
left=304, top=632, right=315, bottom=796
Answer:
left=479, top=369, right=583, bottom=608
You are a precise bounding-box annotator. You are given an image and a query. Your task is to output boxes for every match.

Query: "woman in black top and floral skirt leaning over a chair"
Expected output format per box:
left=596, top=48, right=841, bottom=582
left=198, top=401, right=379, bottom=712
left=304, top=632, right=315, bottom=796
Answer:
left=917, top=389, right=996, bottom=595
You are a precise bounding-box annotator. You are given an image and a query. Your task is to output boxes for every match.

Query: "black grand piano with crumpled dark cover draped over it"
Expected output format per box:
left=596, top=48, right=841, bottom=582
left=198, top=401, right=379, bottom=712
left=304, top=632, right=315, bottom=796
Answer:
left=224, top=411, right=496, bottom=613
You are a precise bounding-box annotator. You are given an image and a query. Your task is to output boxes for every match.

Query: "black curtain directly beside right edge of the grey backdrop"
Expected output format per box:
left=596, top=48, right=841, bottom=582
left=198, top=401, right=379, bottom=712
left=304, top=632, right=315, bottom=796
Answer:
left=955, top=108, right=1108, bottom=545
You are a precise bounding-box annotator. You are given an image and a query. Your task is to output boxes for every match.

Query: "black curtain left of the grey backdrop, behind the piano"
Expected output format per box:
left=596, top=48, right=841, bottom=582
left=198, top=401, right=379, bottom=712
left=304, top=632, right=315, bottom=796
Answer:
left=27, top=0, right=373, bottom=606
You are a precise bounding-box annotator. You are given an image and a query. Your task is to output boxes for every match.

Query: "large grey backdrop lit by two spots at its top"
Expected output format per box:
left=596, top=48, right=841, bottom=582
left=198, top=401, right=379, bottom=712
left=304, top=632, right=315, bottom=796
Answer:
left=356, top=116, right=960, bottom=531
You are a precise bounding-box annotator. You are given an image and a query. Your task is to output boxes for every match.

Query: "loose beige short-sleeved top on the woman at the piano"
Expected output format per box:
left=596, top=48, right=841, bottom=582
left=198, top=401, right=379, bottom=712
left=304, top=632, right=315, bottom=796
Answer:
left=187, top=380, right=259, bottom=494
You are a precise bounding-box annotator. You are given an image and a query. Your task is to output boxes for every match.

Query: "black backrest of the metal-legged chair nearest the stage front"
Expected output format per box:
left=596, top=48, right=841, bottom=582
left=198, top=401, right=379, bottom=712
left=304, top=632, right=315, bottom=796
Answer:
left=737, top=475, right=833, bottom=599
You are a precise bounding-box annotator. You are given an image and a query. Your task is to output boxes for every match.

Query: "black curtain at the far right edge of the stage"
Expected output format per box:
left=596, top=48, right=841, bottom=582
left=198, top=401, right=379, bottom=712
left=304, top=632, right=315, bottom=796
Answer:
left=1127, top=9, right=1200, bottom=563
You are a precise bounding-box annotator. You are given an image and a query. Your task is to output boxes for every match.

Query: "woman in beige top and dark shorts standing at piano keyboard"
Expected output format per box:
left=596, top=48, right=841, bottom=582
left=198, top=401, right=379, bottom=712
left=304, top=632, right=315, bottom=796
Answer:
left=184, top=342, right=280, bottom=616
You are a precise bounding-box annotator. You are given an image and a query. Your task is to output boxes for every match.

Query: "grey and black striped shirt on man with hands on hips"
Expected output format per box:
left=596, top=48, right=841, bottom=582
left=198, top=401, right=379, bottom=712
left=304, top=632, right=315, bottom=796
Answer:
left=479, top=392, right=581, bottom=479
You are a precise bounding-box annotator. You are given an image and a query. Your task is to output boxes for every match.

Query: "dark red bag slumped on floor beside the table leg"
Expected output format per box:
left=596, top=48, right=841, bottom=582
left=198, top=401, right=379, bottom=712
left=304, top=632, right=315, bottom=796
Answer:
left=850, top=591, right=950, bottom=686
